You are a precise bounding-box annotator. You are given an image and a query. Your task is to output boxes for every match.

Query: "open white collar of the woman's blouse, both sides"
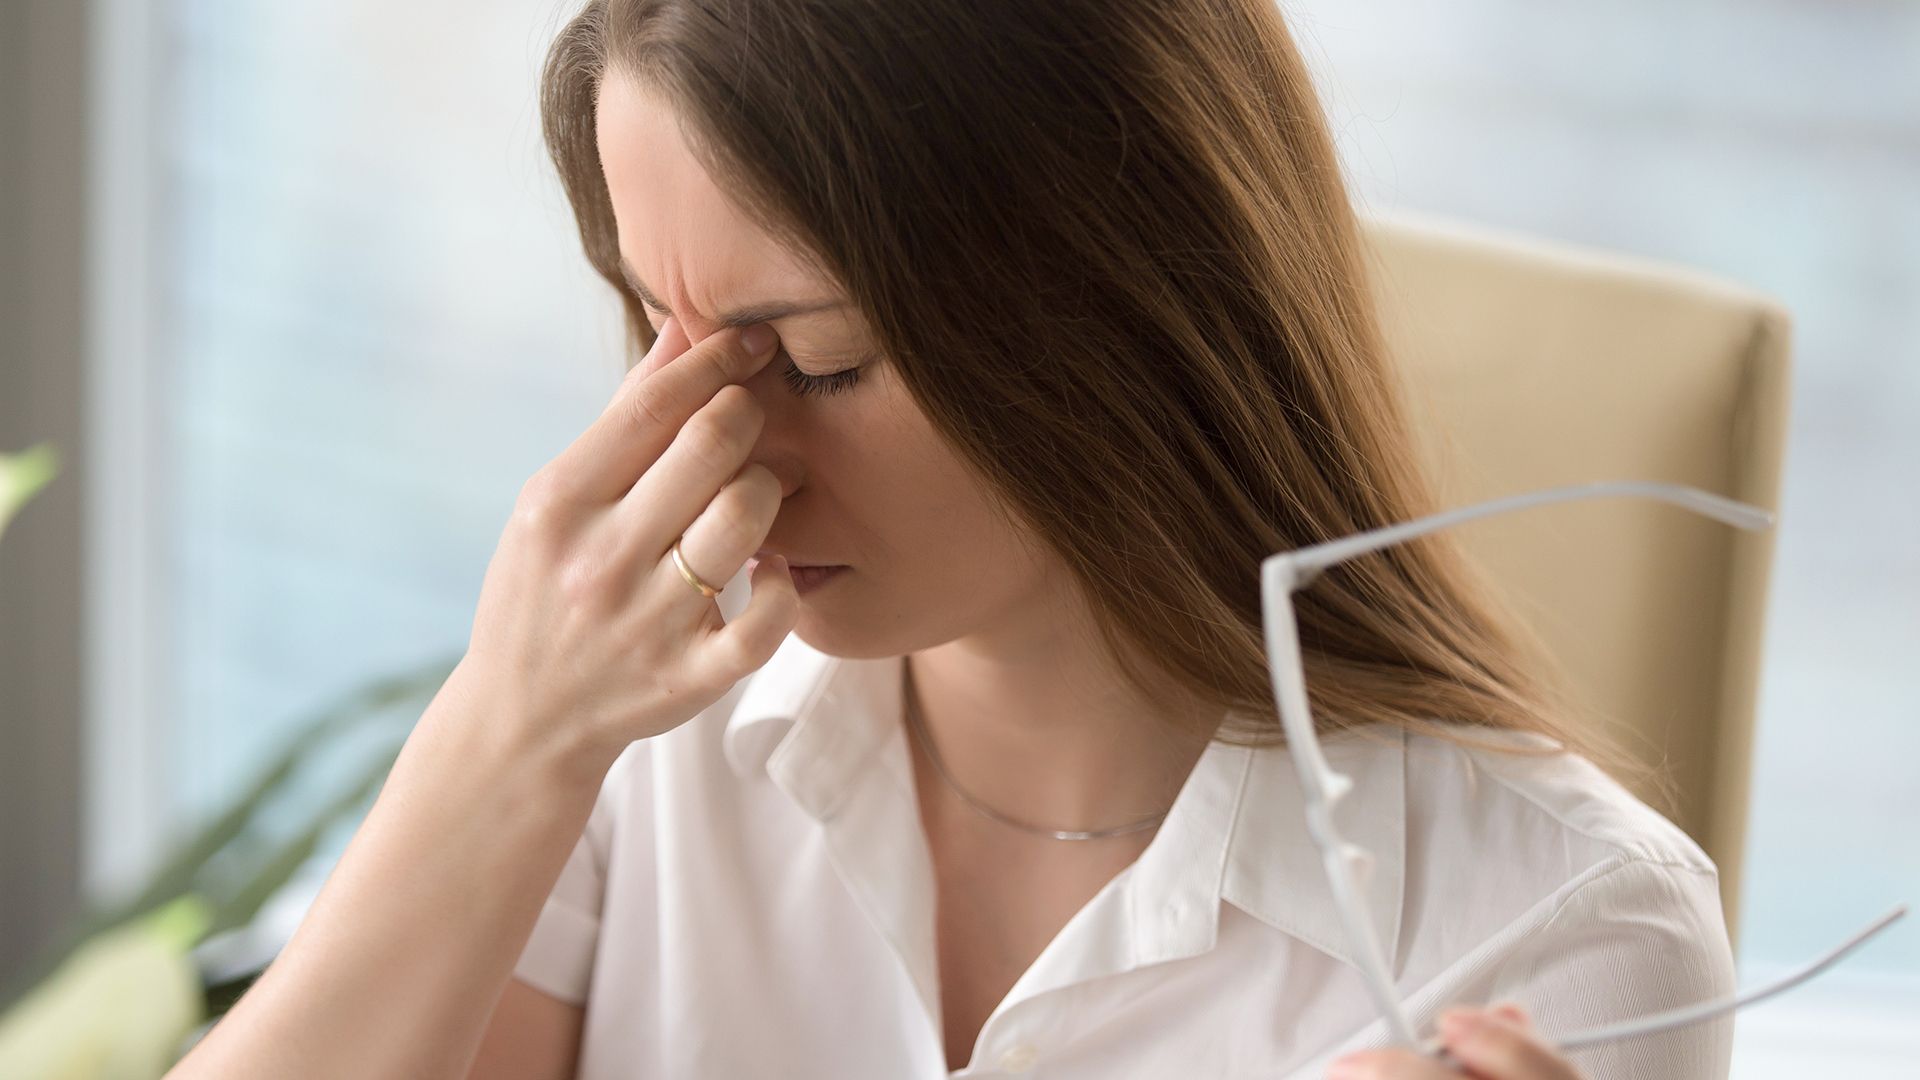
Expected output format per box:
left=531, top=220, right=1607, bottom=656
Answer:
left=722, top=634, right=1407, bottom=970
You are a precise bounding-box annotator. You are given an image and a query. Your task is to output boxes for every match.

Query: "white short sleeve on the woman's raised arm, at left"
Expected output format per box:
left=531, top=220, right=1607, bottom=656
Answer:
left=513, top=749, right=620, bottom=1005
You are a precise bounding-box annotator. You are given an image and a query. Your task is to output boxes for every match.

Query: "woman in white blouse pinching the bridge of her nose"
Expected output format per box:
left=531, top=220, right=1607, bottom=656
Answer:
left=165, top=0, right=1732, bottom=1078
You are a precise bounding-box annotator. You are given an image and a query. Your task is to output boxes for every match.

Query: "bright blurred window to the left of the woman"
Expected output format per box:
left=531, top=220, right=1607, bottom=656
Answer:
left=107, top=0, right=622, bottom=874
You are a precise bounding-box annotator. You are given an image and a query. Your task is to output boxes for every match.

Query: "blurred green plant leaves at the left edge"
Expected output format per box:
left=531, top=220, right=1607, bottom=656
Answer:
left=0, top=444, right=459, bottom=1080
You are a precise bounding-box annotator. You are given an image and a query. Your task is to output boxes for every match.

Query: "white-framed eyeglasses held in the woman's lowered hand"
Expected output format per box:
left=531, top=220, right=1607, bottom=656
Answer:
left=1260, top=482, right=1907, bottom=1061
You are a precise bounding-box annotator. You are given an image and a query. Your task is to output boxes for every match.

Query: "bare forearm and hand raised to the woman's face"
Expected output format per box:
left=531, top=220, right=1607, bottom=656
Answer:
left=167, top=321, right=799, bottom=1080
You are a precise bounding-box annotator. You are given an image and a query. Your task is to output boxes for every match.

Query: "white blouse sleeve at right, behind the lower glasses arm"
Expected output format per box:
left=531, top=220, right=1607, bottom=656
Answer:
left=1492, top=859, right=1736, bottom=1080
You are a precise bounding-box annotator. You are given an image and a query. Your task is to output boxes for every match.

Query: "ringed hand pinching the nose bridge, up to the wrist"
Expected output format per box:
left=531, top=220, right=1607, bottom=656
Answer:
left=447, top=319, right=799, bottom=769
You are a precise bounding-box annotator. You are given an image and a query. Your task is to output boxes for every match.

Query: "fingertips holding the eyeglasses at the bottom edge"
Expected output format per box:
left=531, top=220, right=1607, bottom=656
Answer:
left=1327, top=1005, right=1580, bottom=1080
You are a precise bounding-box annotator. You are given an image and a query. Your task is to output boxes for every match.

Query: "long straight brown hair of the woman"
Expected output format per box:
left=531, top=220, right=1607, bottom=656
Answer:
left=541, top=0, right=1632, bottom=791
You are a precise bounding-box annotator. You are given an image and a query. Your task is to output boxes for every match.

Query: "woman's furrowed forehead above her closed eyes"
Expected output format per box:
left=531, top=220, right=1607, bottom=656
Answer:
left=595, top=69, right=833, bottom=321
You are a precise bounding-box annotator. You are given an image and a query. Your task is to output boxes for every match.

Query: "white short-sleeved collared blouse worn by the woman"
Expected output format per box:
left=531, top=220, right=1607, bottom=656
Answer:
left=515, top=634, right=1734, bottom=1080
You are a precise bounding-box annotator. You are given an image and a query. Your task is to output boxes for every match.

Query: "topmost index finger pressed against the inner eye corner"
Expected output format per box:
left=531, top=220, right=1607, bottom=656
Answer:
left=551, top=323, right=778, bottom=503
